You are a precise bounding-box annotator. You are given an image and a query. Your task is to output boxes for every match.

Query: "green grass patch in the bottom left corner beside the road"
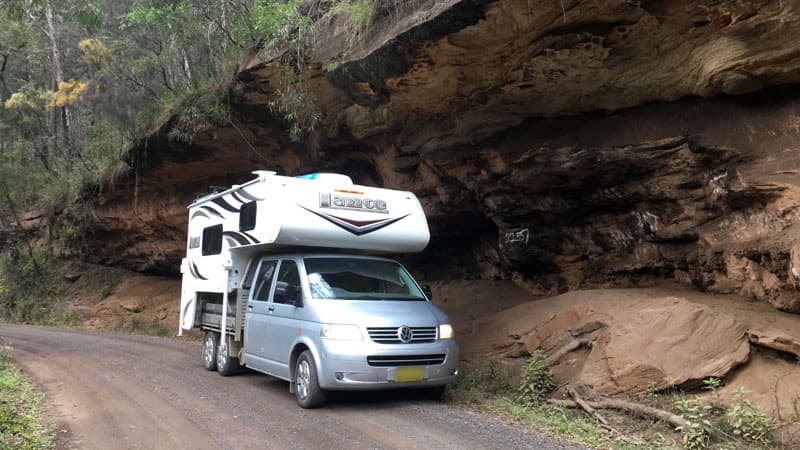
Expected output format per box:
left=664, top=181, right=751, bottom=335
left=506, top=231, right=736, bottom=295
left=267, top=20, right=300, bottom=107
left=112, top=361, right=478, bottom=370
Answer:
left=0, top=341, right=53, bottom=450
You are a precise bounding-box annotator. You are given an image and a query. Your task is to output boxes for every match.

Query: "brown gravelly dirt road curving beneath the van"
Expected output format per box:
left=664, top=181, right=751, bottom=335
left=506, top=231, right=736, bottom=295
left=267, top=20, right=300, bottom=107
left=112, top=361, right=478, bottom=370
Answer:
left=0, top=324, right=580, bottom=449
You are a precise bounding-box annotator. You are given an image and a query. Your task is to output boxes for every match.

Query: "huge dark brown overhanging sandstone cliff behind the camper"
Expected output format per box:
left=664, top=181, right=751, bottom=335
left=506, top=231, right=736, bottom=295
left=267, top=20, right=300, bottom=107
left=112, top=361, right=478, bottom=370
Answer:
left=93, top=0, right=800, bottom=312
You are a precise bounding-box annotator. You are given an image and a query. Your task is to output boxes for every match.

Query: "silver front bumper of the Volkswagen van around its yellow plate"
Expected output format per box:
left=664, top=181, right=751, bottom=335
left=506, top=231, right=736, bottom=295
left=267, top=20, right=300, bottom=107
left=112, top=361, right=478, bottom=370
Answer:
left=317, top=339, right=459, bottom=390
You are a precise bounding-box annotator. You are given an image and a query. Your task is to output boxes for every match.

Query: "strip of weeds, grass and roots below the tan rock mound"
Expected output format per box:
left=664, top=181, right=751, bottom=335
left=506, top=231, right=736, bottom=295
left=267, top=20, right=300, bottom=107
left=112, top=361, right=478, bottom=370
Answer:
left=447, top=351, right=788, bottom=450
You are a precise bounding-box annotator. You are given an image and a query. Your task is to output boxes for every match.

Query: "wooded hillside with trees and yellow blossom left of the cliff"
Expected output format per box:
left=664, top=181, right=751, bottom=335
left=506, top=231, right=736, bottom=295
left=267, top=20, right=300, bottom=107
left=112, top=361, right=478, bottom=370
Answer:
left=0, top=0, right=366, bottom=334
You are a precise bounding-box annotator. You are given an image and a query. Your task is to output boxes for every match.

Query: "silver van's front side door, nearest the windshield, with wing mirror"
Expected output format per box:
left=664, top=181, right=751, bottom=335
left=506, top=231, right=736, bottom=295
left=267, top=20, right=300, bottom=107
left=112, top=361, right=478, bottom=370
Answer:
left=266, top=259, right=303, bottom=377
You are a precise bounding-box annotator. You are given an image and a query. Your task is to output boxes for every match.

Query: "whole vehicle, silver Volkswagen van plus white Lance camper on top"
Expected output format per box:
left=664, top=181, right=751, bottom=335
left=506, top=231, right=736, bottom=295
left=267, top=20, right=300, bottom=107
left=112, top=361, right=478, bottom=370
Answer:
left=178, top=171, right=458, bottom=408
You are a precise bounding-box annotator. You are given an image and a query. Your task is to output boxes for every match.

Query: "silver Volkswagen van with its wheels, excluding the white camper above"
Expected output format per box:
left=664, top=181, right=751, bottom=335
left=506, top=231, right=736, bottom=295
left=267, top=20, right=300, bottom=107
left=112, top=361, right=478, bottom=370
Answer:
left=203, top=254, right=459, bottom=408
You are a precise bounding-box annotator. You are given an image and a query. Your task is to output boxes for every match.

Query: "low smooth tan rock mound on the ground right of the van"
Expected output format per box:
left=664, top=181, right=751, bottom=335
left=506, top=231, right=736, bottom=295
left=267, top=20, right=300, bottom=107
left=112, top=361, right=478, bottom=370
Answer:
left=462, top=289, right=752, bottom=394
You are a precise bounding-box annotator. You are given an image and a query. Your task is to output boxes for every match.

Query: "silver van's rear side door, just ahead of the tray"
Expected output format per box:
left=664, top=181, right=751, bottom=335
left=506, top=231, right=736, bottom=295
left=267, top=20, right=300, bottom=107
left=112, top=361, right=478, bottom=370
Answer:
left=244, top=260, right=278, bottom=367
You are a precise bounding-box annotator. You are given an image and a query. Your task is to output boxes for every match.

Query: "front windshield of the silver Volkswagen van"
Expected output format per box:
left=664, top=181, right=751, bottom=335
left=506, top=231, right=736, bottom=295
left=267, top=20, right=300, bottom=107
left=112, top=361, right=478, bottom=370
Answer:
left=305, top=258, right=425, bottom=301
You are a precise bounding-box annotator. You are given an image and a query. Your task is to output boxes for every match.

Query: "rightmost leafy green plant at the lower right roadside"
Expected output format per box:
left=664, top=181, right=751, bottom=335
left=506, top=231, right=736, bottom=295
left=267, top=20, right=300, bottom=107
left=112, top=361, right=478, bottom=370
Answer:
left=725, top=387, right=777, bottom=447
